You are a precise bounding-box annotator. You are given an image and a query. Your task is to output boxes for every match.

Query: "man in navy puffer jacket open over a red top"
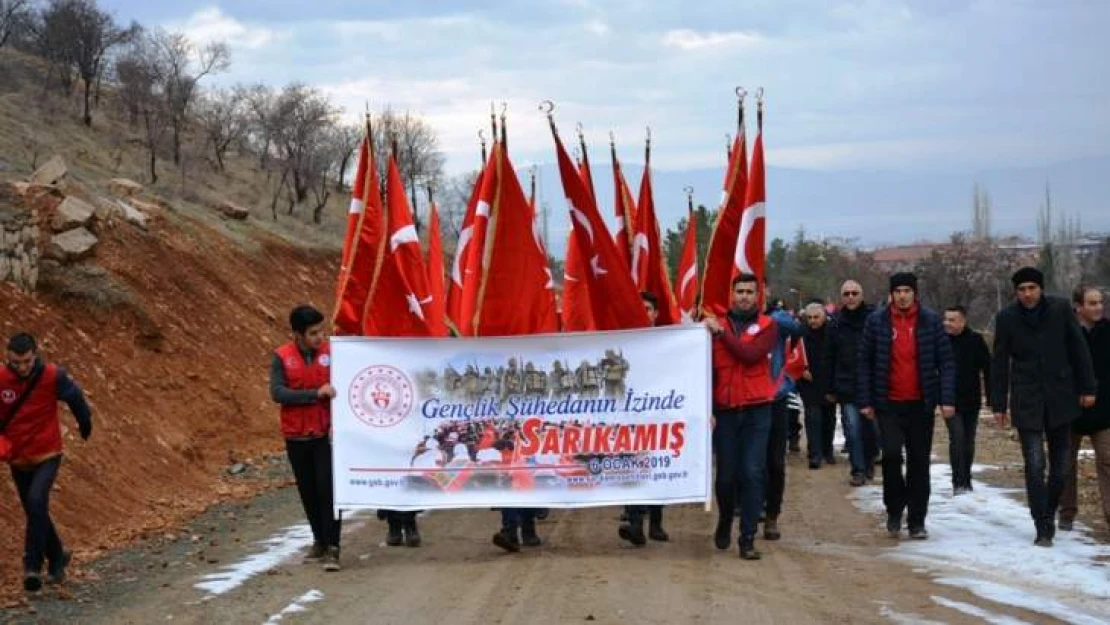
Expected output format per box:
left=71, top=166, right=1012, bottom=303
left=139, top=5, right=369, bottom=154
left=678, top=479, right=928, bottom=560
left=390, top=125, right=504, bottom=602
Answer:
left=857, top=273, right=956, bottom=541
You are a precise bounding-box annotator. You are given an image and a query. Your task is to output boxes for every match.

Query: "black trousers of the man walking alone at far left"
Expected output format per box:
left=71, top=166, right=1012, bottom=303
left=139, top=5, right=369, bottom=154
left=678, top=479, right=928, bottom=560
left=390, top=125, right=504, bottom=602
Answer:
left=11, top=456, right=64, bottom=573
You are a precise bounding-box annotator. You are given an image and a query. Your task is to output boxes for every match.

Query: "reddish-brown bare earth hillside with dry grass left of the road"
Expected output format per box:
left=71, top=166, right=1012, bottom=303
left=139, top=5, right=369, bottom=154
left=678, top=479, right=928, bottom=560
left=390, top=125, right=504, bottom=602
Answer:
left=0, top=50, right=344, bottom=598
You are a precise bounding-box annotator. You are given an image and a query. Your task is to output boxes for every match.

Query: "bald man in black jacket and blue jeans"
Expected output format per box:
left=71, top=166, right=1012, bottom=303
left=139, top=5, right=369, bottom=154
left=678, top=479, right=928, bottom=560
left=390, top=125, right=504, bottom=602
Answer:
left=820, top=280, right=879, bottom=486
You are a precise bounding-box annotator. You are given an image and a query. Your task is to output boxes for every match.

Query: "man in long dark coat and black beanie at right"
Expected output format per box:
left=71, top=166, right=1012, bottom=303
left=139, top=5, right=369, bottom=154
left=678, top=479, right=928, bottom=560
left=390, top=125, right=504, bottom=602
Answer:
left=990, top=266, right=1097, bottom=547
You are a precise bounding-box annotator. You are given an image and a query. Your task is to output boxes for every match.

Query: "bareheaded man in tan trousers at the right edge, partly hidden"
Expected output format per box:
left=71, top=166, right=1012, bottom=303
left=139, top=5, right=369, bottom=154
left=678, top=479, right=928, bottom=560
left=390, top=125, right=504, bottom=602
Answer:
left=1060, top=286, right=1110, bottom=532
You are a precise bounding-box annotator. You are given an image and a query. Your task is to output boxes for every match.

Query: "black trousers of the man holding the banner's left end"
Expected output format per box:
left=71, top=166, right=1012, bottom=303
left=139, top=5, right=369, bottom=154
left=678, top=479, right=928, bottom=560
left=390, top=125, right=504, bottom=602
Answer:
left=285, top=436, right=342, bottom=547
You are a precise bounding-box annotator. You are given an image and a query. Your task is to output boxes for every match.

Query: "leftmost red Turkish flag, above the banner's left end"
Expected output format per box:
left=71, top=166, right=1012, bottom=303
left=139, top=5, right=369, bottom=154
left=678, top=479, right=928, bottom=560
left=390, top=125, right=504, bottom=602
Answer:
left=334, top=132, right=385, bottom=335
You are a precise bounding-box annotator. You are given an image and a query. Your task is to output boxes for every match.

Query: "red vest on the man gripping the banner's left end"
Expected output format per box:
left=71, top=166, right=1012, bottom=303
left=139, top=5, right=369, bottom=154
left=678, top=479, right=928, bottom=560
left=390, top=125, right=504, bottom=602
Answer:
left=276, top=342, right=332, bottom=438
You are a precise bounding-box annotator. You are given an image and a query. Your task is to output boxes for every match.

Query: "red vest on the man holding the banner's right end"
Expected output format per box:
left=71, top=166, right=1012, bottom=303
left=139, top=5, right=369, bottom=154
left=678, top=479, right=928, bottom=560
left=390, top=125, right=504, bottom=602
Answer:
left=713, top=314, right=776, bottom=410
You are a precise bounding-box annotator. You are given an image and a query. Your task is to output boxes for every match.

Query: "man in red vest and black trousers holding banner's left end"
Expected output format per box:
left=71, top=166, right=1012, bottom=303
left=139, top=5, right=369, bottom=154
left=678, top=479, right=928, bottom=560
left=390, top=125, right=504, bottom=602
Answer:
left=270, top=305, right=341, bottom=571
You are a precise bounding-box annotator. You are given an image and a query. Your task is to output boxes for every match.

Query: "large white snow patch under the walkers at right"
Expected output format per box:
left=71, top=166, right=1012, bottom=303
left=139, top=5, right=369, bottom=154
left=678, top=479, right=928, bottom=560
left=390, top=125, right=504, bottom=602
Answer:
left=849, top=464, right=1110, bottom=625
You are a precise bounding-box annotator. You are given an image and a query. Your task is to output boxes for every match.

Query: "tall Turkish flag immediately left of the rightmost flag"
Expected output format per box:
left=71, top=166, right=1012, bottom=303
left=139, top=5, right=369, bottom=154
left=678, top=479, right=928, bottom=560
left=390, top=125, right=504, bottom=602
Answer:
left=702, top=131, right=747, bottom=316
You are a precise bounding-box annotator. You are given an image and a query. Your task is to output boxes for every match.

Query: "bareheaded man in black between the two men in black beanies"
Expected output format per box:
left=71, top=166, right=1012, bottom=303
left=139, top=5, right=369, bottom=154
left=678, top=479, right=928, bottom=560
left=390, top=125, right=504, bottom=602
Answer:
left=945, top=305, right=990, bottom=495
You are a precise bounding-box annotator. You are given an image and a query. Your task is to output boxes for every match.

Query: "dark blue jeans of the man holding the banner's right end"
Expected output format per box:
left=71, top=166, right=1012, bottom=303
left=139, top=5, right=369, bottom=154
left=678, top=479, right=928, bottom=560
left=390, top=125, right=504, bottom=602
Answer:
left=713, top=404, right=771, bottom=540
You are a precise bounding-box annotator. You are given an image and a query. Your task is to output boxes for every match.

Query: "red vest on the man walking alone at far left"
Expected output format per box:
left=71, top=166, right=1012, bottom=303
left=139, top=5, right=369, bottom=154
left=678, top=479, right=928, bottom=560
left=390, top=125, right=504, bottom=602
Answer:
left=0, top=364, right=62, bottom=466
